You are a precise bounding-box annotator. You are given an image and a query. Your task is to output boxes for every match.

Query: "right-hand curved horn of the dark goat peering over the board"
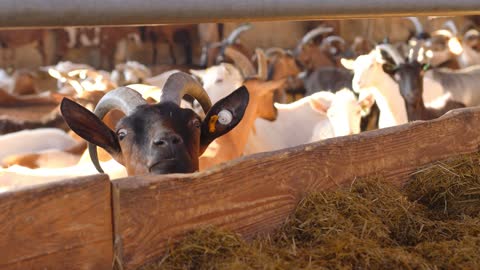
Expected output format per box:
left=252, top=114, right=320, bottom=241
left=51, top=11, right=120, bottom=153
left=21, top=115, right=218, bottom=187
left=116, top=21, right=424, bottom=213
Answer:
left=160, top=72, right=212, bottom=113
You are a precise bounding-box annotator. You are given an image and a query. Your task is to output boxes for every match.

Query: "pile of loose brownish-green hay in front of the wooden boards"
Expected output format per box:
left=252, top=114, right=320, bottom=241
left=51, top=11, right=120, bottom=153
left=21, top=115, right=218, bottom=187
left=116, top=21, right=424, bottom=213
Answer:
left=142, top=154, right=480, bottom=270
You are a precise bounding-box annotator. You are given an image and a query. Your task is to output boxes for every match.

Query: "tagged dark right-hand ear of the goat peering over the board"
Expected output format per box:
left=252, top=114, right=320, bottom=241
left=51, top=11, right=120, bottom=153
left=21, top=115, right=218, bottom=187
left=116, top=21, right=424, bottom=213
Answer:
left=200, top=86, right=249, bottom=154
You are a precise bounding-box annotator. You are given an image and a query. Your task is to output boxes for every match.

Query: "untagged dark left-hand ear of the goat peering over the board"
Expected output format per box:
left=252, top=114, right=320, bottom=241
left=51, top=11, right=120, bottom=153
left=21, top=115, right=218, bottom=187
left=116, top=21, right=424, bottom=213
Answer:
left=60, top=98, right=121, bottom=155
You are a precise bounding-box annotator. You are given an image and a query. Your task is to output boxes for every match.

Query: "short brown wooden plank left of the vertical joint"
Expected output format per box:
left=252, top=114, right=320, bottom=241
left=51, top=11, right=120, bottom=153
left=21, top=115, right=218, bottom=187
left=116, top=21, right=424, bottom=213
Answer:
left=0, top=175, right=113, bottom=269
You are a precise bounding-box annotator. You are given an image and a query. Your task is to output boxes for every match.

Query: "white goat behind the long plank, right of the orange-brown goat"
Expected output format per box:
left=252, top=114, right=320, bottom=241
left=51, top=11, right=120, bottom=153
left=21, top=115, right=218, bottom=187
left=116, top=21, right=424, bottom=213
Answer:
left=245, top=89, right=373, bottom=154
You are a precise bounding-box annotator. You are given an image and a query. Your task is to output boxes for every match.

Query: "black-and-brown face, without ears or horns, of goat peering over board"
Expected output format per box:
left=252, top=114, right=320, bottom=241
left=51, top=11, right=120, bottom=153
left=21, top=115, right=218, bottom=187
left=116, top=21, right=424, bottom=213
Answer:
left=115, top=103, right=201, bottom=174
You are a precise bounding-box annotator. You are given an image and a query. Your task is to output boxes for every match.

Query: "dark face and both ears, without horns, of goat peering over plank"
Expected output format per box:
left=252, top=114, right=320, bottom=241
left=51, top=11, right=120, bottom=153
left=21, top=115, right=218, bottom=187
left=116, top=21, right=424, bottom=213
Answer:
left=61, top=76, right=249, bottom=175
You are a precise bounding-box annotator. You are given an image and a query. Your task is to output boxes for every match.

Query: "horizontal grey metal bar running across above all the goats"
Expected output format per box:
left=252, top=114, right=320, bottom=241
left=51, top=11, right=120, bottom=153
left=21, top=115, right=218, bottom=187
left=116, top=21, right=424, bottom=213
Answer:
left=0, top=0, right=480, bottom=27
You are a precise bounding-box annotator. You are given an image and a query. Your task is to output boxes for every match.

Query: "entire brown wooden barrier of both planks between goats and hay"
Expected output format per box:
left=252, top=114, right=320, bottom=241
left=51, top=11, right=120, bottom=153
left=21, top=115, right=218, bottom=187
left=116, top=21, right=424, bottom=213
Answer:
left=0, top=108, right=480, bottom=269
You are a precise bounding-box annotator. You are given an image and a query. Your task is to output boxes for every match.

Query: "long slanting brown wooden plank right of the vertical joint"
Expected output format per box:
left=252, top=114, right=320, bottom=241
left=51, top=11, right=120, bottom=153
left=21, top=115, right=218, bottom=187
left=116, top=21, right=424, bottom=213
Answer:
left=112, top=108, right=480, bottom=269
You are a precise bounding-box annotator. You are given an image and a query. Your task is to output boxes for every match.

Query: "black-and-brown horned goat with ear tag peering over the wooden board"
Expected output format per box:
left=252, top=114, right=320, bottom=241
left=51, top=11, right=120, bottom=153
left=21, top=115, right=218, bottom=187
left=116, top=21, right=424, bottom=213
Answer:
left=61, top=72, right=249, bottom=175
